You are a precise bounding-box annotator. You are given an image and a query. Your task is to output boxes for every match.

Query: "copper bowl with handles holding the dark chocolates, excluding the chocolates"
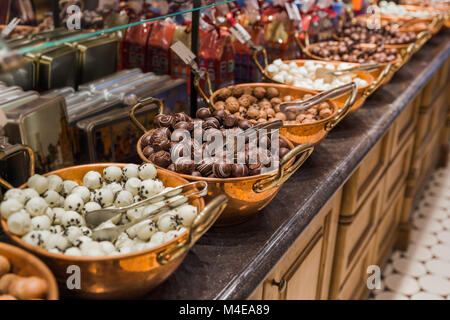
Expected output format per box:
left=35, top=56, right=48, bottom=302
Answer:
left=130, top=104, right=314, bottom=226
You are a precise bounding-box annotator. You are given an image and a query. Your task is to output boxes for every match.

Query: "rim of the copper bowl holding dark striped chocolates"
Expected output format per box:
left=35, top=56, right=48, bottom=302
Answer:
left=137, top=129, right=295, bottom=183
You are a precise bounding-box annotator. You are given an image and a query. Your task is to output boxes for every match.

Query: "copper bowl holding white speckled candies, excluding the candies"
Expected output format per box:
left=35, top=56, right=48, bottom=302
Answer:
left=1, top=163, right=226, bottom=299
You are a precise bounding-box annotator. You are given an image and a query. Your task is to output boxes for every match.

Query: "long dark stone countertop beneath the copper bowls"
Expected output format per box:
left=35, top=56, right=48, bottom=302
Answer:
left=0, top=31, right=450, bottom=299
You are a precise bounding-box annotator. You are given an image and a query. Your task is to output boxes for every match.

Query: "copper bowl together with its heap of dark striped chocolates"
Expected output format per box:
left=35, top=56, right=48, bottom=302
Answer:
left=137, top=108, right=314, bottom=226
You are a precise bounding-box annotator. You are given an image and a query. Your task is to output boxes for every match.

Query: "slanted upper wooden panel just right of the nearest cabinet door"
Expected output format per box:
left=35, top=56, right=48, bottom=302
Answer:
left=340, top=129, right=392, bottom=216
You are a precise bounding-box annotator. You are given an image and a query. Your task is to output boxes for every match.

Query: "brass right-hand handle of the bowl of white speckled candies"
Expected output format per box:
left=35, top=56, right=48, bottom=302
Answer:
left=157, top=194, right=228, bottom=266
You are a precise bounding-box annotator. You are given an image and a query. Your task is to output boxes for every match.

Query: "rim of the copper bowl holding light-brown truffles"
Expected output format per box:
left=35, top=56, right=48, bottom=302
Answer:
left=209, top=82, right=339, bottom=130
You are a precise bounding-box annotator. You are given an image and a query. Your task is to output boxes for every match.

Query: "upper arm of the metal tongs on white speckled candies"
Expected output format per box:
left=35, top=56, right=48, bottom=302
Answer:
left=84, top=181, right=208, bottom=228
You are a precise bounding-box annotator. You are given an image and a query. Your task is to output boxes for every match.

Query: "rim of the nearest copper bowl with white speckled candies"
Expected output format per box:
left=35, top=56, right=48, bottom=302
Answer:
left=0, top=164, right=205, bottom=262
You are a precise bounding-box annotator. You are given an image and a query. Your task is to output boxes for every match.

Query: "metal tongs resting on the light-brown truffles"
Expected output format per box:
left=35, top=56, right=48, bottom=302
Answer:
left=280, top=82, right=356, bottom=113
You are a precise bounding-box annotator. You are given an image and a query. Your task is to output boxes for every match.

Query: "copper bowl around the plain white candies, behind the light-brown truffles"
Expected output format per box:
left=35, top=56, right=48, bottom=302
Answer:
left=253, top=57, right=374, bottom=112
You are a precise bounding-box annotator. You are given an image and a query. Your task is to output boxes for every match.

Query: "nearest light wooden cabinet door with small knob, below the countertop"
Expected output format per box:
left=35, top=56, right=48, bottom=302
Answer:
left=251, top=192, right=342, bottom=300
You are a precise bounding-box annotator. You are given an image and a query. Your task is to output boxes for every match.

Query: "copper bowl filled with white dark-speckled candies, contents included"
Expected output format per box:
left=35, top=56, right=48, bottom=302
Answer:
left=0, top=164, right=226, bottom=299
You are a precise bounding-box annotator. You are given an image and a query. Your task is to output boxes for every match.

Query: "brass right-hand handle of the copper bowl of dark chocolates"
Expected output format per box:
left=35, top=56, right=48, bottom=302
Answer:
left=253, top=142, right=314, bottom=193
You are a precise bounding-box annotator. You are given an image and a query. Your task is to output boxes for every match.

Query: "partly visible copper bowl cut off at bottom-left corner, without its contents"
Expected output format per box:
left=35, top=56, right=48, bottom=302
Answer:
left=0, top=242, right=59, bottom=300
